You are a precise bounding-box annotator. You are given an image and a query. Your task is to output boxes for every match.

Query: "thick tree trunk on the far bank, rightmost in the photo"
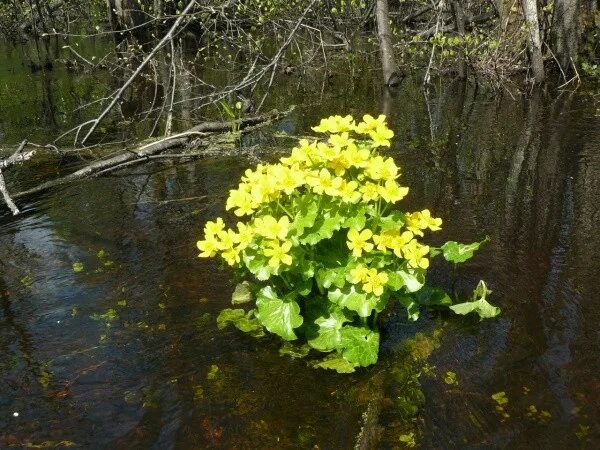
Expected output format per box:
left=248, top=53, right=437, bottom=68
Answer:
left=552, top=0, right=581, bottom=73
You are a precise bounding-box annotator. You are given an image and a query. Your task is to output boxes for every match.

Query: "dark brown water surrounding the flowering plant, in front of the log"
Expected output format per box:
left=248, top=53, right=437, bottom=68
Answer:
left=0, top=40, right=600, bottom=449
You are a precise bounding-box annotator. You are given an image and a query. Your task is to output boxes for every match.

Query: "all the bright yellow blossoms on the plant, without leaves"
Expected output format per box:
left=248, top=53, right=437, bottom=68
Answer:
left=197, top=115, right=442, bottom=282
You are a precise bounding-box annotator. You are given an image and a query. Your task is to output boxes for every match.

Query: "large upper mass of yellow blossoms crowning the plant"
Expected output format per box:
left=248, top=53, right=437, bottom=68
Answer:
left=225, top=115, right=408, bottom=217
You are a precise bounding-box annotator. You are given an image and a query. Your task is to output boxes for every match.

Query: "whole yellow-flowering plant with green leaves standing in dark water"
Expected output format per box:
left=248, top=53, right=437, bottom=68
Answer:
left=197, top=115, right=499, bottom=372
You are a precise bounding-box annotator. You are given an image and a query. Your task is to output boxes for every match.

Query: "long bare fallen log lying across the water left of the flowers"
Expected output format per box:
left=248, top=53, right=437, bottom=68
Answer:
left=0, top=108, right=293, bottom=215
